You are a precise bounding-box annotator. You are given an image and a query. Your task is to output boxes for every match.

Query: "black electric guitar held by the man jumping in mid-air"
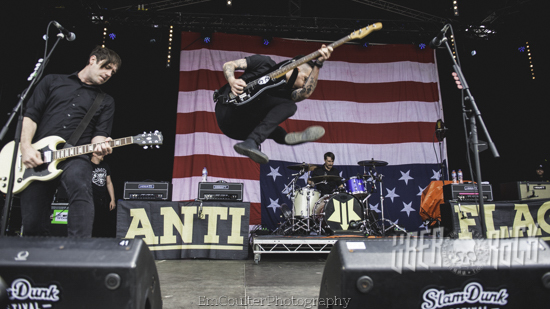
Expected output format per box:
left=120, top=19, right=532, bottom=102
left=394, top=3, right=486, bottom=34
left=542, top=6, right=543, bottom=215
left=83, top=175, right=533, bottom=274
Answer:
left=214, top=23, right=382, bottom=106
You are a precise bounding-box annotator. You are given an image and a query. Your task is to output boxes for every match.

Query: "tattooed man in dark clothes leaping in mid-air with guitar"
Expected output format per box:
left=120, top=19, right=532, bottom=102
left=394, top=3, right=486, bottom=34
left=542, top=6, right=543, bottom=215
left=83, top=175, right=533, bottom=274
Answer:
left=216, top=44, right=332, bottom=164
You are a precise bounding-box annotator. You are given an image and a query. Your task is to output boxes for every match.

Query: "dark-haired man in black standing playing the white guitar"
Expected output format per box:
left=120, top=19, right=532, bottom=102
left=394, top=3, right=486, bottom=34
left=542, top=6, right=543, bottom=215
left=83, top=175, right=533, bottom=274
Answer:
left=21, top=46, right=122, bottom=237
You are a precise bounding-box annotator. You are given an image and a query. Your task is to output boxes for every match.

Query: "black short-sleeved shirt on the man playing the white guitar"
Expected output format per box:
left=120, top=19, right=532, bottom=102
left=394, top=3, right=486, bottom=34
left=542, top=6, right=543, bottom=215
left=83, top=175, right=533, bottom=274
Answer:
left=24, top=73, right=115, bottom=146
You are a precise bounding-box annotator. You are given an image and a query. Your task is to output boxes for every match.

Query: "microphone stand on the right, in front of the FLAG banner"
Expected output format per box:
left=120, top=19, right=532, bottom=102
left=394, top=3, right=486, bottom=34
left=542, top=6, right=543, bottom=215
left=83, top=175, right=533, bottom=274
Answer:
left=442, top=37, right=500, bottom=238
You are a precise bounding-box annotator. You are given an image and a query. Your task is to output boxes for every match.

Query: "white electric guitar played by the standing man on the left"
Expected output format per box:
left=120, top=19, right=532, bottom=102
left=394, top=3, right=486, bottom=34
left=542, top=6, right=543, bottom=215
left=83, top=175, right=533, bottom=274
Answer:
left=0, top=131, right=163, bottom=194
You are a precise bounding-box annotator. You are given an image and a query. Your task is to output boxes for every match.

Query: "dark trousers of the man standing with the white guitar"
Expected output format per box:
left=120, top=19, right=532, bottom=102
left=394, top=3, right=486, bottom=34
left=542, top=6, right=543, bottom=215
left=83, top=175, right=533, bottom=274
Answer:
left=21, top=155, right=94, bottom=237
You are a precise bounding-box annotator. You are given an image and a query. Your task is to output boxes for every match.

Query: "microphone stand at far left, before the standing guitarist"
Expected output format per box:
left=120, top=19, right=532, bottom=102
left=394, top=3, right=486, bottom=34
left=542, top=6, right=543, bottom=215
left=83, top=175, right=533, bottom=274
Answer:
left=0, top=33, right=65, bottom=237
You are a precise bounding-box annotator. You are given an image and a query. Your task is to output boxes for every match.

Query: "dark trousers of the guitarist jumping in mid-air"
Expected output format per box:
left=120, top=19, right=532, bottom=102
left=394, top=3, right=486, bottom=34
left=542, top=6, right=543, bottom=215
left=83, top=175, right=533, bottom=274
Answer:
left=216, top=95, right=298, bottom=145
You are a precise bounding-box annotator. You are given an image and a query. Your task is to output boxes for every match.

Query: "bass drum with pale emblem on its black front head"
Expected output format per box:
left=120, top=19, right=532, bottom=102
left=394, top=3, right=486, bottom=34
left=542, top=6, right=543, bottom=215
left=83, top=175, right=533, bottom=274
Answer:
left=322, top=193, right=364, bottom=232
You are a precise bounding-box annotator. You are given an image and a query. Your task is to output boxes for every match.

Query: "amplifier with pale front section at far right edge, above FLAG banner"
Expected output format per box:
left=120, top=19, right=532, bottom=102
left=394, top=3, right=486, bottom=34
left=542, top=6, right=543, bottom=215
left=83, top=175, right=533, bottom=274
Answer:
left=500, top=181, right=550, bottom=201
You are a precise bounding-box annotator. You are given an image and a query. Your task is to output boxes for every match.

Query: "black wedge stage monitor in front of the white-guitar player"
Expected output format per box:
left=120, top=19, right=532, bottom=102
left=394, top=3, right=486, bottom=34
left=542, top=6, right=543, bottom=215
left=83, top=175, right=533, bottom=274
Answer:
left=0, top=237, right=162, bottom=309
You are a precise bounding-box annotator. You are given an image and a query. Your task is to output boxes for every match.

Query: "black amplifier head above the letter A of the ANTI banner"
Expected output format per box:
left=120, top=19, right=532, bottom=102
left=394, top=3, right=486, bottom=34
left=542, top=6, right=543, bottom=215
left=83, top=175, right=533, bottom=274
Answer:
left=124, top=181, right=172, bottom=201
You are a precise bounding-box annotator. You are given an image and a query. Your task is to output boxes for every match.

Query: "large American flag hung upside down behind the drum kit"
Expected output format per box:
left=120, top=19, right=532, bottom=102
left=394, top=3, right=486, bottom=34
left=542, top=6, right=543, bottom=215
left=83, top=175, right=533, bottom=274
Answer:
left=172, top=32, right=446, bottom=231
